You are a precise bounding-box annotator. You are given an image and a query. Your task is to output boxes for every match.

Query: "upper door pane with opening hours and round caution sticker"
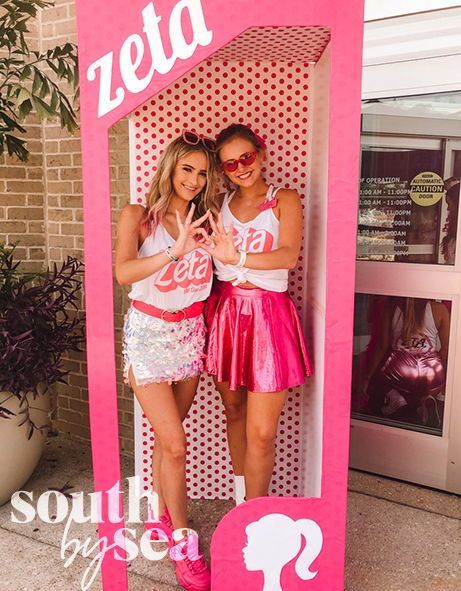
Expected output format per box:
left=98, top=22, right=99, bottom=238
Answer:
left=357, top=138, right=459, bottom=264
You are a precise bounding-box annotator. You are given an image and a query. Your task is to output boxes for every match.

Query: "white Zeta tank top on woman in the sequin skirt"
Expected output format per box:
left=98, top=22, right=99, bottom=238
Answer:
left=128, top=224, right=213, bottom=312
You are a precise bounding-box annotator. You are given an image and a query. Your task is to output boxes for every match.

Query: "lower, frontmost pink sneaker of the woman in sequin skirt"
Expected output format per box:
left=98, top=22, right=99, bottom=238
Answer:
left=170, top=530, right=211, bottom=591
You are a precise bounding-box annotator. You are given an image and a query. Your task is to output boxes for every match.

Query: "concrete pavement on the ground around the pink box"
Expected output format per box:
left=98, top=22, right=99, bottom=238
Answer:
left=0, top=435, right=461, bottom=591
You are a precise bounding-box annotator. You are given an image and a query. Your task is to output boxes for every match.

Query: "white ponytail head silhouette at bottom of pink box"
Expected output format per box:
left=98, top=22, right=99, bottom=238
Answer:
left=243, top=513, right=323, bottom=591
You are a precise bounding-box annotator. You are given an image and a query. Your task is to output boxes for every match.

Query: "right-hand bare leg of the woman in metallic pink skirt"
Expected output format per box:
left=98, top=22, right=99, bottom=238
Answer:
left=245, top=390, right=287, bottom=499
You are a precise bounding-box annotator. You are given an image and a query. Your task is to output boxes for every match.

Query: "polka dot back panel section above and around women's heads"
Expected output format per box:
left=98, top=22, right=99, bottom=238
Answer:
left=131, top=61, right=309, bottom=208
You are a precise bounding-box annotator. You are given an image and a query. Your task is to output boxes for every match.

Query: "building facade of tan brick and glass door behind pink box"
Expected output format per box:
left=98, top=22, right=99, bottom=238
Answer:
left=0, top=0, right=461, bottom=493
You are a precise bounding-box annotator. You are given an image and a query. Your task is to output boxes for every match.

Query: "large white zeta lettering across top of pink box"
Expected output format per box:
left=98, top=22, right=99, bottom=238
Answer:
left=87, top=0, right=213, bottom=117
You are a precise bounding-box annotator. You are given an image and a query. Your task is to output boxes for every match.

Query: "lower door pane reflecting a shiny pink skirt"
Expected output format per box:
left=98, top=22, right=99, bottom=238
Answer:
left=352, top=294, right=451, bottom=437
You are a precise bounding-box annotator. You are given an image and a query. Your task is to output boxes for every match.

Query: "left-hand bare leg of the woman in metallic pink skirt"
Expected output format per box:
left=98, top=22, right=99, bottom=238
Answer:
left=216, top=382, right=247, bottom=476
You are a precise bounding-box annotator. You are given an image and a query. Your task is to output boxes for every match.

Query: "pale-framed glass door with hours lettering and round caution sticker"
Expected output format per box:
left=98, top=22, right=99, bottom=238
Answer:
left=351, top=93, right=461, bottom=493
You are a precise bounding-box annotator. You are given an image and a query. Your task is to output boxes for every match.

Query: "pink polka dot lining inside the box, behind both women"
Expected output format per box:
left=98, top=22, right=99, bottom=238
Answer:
left=130, top=53, right=312, bottom=499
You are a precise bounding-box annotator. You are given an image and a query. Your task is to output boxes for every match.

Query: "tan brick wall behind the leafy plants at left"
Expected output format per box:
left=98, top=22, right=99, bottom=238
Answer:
left=0, top=0, right=133, bottom=453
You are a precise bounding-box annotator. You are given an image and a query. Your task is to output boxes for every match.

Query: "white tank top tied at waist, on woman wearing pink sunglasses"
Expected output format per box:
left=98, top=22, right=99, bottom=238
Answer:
left=214, top=185, right=288, bottom=292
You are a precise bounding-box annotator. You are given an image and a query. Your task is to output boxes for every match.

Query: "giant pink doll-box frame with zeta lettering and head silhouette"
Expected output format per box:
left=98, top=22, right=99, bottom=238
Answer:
left=77, top=0, right=363, bottom=591
